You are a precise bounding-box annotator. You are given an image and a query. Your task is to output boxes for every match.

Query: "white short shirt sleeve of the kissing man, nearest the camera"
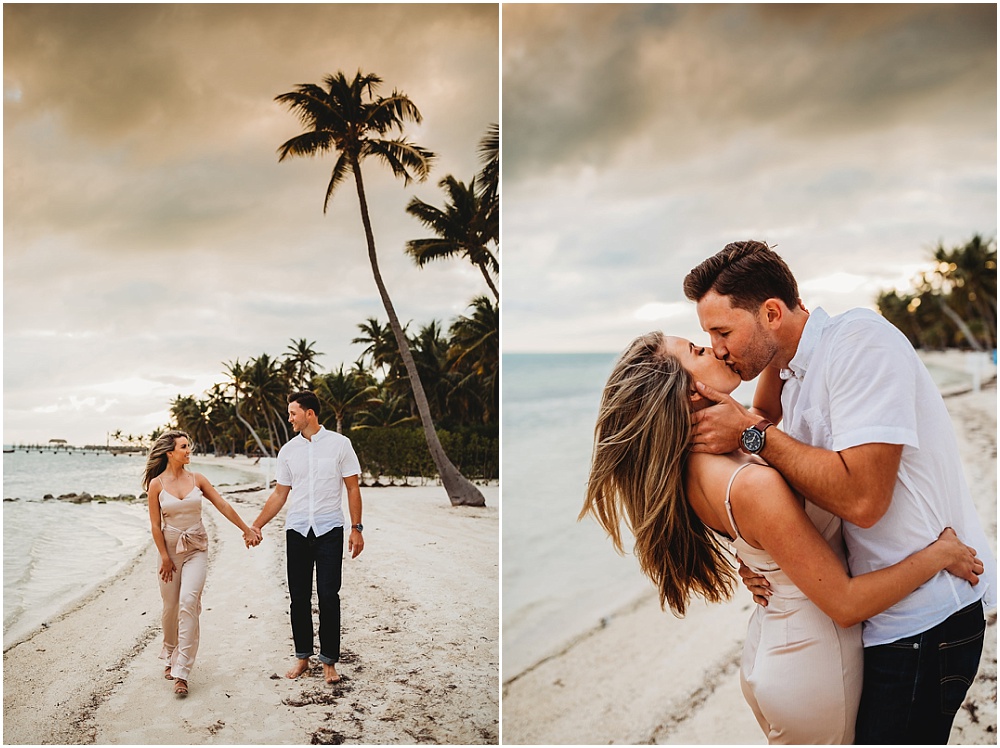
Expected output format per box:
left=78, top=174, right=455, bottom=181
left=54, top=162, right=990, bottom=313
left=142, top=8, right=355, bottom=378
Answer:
left=826, top=318, right=920, bottom=452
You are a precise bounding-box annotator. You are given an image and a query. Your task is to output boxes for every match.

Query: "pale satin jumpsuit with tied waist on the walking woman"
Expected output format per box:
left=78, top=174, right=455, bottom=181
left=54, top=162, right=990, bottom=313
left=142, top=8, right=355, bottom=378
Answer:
left=159, top=486, right=208, bottom=680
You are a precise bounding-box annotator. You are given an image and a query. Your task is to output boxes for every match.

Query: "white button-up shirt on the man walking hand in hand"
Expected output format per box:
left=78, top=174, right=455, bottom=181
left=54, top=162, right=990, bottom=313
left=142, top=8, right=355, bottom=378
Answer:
left=275, top=426, right=361, bottom=537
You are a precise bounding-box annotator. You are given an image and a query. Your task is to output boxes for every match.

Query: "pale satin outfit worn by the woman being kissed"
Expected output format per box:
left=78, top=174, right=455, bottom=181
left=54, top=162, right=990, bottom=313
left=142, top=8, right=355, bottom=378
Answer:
left=726, top=465, right=864, bottom=745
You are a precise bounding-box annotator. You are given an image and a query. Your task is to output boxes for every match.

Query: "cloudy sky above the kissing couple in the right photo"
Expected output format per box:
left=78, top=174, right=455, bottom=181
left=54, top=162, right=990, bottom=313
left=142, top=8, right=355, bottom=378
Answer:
left=502, top=4, right=997, bottom=352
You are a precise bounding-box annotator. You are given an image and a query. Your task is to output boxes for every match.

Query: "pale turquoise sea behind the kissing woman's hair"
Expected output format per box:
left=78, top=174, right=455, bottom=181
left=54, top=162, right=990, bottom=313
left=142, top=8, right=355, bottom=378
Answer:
left=501, top=354, right=648, bottom=680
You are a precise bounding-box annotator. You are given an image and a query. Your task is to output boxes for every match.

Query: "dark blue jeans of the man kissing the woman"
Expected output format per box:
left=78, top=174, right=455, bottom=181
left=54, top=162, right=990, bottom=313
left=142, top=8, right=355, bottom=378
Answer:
left=854, top=602, right=986, bottom=745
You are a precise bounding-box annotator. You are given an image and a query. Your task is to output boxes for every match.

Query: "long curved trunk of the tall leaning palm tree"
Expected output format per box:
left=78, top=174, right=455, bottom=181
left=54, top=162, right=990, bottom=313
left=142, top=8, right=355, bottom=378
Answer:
left=352, top=159, right=486, bottom=506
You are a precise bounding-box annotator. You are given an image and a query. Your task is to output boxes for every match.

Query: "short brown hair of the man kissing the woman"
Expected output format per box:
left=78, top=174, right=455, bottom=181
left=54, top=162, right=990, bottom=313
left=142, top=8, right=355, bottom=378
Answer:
left=684, top=240, right=799, bottom=312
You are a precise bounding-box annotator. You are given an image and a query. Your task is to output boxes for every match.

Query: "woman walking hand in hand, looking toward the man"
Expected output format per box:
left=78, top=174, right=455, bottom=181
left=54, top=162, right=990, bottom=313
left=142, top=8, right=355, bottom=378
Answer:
left=142, top=431, right=261, bottom=696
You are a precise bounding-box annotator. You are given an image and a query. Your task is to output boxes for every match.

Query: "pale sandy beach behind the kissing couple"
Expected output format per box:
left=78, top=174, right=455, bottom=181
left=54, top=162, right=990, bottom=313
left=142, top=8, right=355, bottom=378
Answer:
left=503, top=380, right=997, bottom=745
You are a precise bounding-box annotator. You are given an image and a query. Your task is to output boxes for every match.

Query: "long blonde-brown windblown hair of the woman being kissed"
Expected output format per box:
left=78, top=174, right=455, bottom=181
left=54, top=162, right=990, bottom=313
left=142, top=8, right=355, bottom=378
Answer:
left=580, top=332, right=735, bottom=616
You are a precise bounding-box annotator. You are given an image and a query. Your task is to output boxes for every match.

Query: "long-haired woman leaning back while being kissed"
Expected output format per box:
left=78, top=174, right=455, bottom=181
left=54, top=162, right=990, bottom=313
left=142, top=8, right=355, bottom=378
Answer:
left=580, top=332, right=983, bottom=744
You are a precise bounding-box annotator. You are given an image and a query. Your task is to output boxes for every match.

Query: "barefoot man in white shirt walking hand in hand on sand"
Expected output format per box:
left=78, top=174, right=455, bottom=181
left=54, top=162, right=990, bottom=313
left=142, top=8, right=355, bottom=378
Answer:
left=252, top=391, right=365, bottom=683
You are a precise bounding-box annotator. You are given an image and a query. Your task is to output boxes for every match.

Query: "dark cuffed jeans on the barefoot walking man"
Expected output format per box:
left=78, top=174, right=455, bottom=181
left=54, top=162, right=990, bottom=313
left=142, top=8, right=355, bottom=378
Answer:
left=285, top=527, right=344, bottom=665
